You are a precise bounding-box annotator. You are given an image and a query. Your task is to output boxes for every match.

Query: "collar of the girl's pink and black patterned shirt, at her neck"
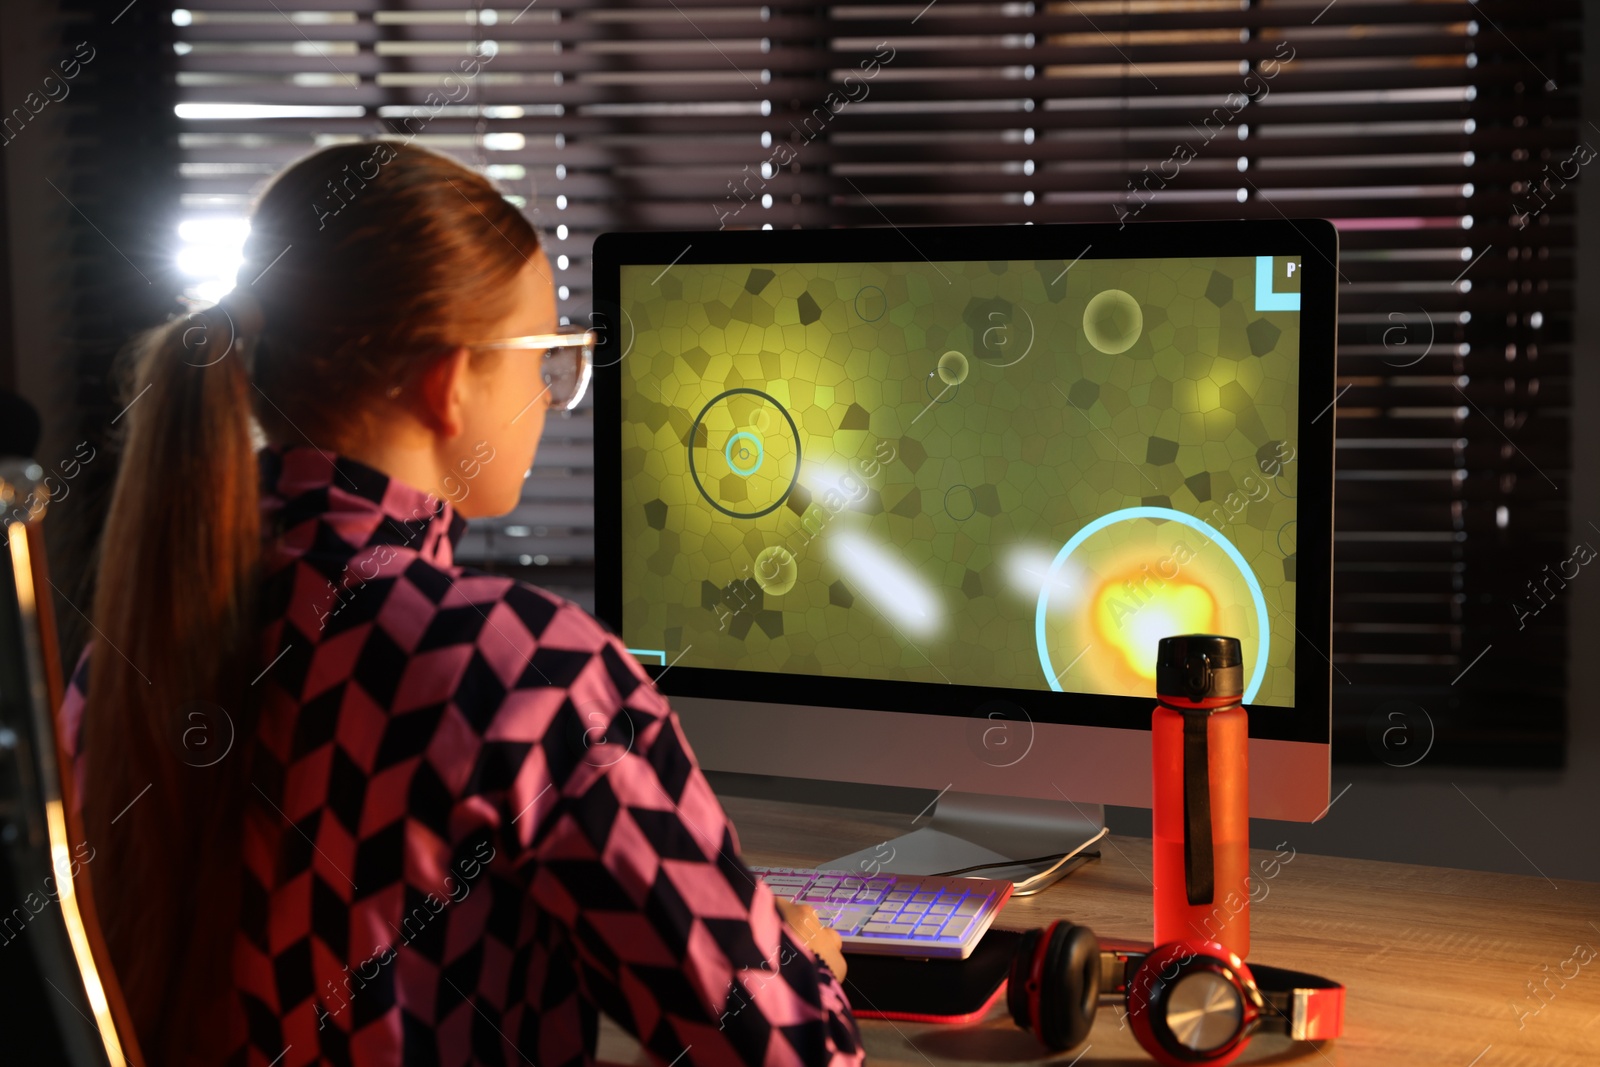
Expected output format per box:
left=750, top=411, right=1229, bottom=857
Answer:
left=256, top=445, right=467, bottom=568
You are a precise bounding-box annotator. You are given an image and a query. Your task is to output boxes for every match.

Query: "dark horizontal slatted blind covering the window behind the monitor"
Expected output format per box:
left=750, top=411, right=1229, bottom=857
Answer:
left=173, top=0, right=1574, bottom=766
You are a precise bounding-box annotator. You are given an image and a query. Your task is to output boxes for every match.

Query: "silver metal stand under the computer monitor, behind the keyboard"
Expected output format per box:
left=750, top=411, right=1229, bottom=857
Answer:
left=819, top=792, right=1106, bottom=893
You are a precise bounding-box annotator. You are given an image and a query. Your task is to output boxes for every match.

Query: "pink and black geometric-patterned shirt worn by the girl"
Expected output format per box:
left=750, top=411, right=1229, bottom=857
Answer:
left=62, top=446, right=862, bottom=1067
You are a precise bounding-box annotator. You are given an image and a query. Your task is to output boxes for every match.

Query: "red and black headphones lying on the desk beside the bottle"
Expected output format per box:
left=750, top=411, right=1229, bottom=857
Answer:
left=1006, top=920, right=1344, bottom=1067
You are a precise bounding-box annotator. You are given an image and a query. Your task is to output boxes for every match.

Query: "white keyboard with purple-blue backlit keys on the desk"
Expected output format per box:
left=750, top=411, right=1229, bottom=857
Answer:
left=750, top=867, right=1013, bottom=960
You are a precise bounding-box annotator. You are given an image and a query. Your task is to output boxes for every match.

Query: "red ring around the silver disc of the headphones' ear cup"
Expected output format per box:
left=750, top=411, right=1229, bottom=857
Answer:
left=1128, top=941, right=1258, bottom=1067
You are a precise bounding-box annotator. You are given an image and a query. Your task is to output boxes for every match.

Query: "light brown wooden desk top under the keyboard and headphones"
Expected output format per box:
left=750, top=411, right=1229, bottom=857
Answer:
left=600, top=797, right=1600, bottom=1067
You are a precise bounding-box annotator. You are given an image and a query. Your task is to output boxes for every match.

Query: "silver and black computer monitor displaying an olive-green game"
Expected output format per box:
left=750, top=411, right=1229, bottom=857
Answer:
left=592, top=219, right=1338, bottom=873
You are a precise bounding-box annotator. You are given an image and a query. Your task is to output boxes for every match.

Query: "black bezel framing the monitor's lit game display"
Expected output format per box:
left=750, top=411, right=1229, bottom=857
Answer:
left=592, top=219, right=1339, bottom=744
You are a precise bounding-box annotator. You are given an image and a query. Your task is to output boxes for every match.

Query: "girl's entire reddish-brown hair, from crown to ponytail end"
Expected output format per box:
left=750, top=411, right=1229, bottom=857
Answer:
left=82, top=141, right=539, bottom=1065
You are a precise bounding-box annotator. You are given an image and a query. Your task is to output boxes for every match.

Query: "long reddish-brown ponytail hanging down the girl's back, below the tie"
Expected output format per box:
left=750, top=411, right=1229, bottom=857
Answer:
left=83, top=287, right=261, bottom=1064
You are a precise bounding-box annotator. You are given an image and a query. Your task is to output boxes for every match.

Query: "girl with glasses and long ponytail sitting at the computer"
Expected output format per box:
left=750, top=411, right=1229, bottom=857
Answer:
left=62, top=142, right=861, bottom=1067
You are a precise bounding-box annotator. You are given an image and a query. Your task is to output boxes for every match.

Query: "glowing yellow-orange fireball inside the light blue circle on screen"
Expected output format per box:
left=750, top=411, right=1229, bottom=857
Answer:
left=1090, top=568, right=1218, bottom=681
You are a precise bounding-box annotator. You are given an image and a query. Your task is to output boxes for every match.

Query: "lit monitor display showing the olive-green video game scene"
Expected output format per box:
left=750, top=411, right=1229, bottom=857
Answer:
left=597, top=224, right=1333, bottom=739
